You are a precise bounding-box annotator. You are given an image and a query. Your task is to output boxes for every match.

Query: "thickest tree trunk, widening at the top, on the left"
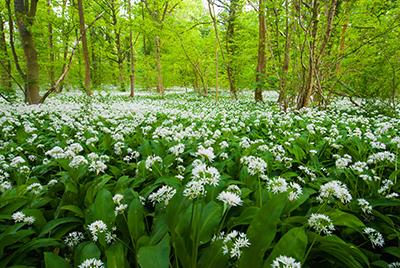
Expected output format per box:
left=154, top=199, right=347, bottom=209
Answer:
left=14, top=0, right=41, bottom=104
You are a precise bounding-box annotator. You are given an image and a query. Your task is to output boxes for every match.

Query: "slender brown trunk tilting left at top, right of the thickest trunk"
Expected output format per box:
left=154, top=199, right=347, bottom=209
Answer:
left=78, top=0, right=92, bottom=96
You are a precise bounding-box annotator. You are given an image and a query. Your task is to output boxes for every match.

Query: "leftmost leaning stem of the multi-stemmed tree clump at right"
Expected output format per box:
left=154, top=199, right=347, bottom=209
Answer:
left=297, top=0, right=319, bottom=109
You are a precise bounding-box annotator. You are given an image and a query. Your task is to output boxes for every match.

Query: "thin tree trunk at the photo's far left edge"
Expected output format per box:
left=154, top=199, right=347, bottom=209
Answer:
left=0, top=14, right=12, bottom=93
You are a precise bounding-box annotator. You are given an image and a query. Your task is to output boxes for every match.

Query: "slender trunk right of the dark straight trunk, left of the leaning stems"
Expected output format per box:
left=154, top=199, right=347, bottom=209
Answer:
left=278, top=0, right=291, bottom=111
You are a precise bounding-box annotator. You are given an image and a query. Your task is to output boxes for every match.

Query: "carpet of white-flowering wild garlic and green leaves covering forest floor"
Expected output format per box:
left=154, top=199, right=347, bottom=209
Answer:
left=0, top=90, right=400, bottom=268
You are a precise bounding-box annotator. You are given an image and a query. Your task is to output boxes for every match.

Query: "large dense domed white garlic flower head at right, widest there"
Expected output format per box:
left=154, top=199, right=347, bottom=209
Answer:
left=317, top=180, right=352, bottom=204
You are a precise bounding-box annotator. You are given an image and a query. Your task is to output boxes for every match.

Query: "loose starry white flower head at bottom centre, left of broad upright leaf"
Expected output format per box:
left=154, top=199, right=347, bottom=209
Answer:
left=212, top=230, right=251, bottom=259
